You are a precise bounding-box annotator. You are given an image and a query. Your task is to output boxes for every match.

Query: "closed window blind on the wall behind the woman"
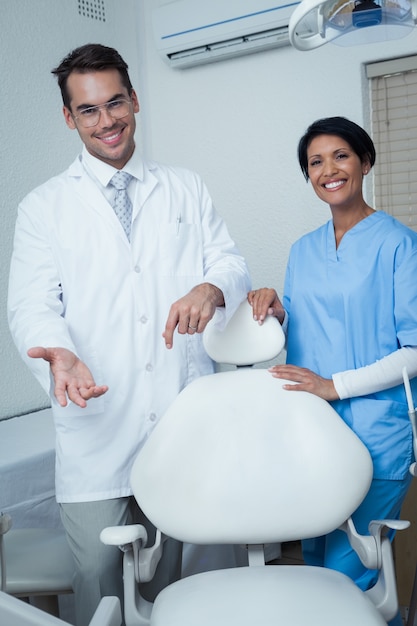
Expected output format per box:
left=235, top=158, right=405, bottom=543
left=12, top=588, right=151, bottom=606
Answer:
left=366, top=56, right=417, bottom=230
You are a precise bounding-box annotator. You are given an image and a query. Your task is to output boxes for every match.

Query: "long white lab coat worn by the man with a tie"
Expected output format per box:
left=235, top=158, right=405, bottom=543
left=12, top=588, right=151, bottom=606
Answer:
left=9, top=155, right=250, bottom=502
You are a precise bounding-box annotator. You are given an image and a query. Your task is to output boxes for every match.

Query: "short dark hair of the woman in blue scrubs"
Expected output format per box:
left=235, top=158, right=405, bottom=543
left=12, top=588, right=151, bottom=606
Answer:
left=298, top=117, right=376, bottom=180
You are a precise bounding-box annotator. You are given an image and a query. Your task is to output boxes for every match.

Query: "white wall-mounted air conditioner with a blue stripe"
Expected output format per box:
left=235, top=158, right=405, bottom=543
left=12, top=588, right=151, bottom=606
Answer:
left=153, top=0, right=300, bottom=68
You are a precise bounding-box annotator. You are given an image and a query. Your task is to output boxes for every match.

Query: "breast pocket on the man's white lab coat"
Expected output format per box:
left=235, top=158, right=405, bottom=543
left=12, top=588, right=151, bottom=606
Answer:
left=158, top=219, right=203, bottom=276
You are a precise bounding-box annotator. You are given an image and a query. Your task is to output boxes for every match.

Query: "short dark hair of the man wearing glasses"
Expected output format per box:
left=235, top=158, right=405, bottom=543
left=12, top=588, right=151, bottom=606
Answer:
left=52, top=43, right=133, bottom=109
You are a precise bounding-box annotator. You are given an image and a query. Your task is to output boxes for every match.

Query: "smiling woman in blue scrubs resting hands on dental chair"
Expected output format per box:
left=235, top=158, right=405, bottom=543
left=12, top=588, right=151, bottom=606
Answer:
left=248, top=117, right=417, bottom=626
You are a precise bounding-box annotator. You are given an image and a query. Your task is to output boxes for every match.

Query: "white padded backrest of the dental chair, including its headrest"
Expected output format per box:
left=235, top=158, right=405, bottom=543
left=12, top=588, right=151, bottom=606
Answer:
left=131, top=303, right=372, bottom=544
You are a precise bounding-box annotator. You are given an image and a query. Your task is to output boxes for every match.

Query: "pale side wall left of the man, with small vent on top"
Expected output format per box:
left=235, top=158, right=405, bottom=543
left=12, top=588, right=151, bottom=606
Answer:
left=0, top=0, right=139, bottom=419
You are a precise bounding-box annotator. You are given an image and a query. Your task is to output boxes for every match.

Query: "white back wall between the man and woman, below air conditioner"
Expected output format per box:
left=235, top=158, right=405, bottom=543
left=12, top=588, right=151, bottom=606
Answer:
left=139, top=0, right=417, bottom=290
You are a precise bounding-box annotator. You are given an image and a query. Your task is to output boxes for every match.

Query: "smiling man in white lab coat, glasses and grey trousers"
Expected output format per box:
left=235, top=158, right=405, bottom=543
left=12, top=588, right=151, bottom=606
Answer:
left=9, top=44, right=250, bottom=626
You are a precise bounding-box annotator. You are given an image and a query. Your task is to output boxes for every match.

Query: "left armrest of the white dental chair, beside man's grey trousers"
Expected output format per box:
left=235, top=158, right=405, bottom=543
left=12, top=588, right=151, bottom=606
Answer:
left=100, top=524, right=166, bottom=583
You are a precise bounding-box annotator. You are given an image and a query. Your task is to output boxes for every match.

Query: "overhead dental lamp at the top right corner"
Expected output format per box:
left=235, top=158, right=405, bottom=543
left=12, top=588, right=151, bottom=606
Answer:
left=289, top=0, right=417, bottom=50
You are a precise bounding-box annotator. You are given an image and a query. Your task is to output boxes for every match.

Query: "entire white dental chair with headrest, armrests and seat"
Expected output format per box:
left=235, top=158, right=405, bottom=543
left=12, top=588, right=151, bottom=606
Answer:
left=101, top=302, right=408, bottom=626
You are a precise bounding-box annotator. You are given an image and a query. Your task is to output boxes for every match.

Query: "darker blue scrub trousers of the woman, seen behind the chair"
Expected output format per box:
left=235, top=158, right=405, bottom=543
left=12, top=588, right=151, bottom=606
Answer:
left=302, top=474, right=412, bottom=626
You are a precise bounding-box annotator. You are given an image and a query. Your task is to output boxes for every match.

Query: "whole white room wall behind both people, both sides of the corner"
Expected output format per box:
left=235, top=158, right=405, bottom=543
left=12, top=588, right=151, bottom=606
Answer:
left=0, top=0, right=417, bottom=417
